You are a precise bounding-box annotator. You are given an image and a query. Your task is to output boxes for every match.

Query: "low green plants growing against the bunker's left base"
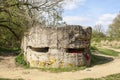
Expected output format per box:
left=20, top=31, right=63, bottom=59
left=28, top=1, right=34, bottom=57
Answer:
left=15, top=53, right=29, bottom=68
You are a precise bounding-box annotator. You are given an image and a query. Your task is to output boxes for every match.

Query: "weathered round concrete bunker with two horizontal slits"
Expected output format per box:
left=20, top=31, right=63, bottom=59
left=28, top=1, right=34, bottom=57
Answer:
left=22, top=25, right=92, bottom=68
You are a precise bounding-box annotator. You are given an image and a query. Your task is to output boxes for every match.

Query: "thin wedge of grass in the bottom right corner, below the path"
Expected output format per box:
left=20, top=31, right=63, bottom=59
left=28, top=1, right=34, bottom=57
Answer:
left=83, top=73, right=120, bottom=80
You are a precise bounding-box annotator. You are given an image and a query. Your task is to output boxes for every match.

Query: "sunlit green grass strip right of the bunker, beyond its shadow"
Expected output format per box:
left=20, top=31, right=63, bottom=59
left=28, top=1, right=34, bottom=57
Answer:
left=98, top=48, right=120, bottom=57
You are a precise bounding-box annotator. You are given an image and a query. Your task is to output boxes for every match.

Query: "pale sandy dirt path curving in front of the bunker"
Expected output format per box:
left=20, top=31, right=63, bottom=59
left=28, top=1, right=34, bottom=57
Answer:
left=0, top=52, right=120, bottom=80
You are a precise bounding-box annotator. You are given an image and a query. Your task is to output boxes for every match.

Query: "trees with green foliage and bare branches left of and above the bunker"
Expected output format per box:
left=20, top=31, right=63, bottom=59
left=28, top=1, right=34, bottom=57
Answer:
left=0, top=0, right=63, bottom=48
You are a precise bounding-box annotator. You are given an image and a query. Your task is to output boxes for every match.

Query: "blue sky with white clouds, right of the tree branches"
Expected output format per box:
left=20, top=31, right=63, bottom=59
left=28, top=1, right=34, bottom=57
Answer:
left=63, top=0, right=120, bottom=27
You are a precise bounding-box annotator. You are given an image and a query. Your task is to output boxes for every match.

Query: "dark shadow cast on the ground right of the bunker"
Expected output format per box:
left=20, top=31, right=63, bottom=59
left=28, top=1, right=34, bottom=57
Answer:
left=91, top=54, right=114, bottom=67
